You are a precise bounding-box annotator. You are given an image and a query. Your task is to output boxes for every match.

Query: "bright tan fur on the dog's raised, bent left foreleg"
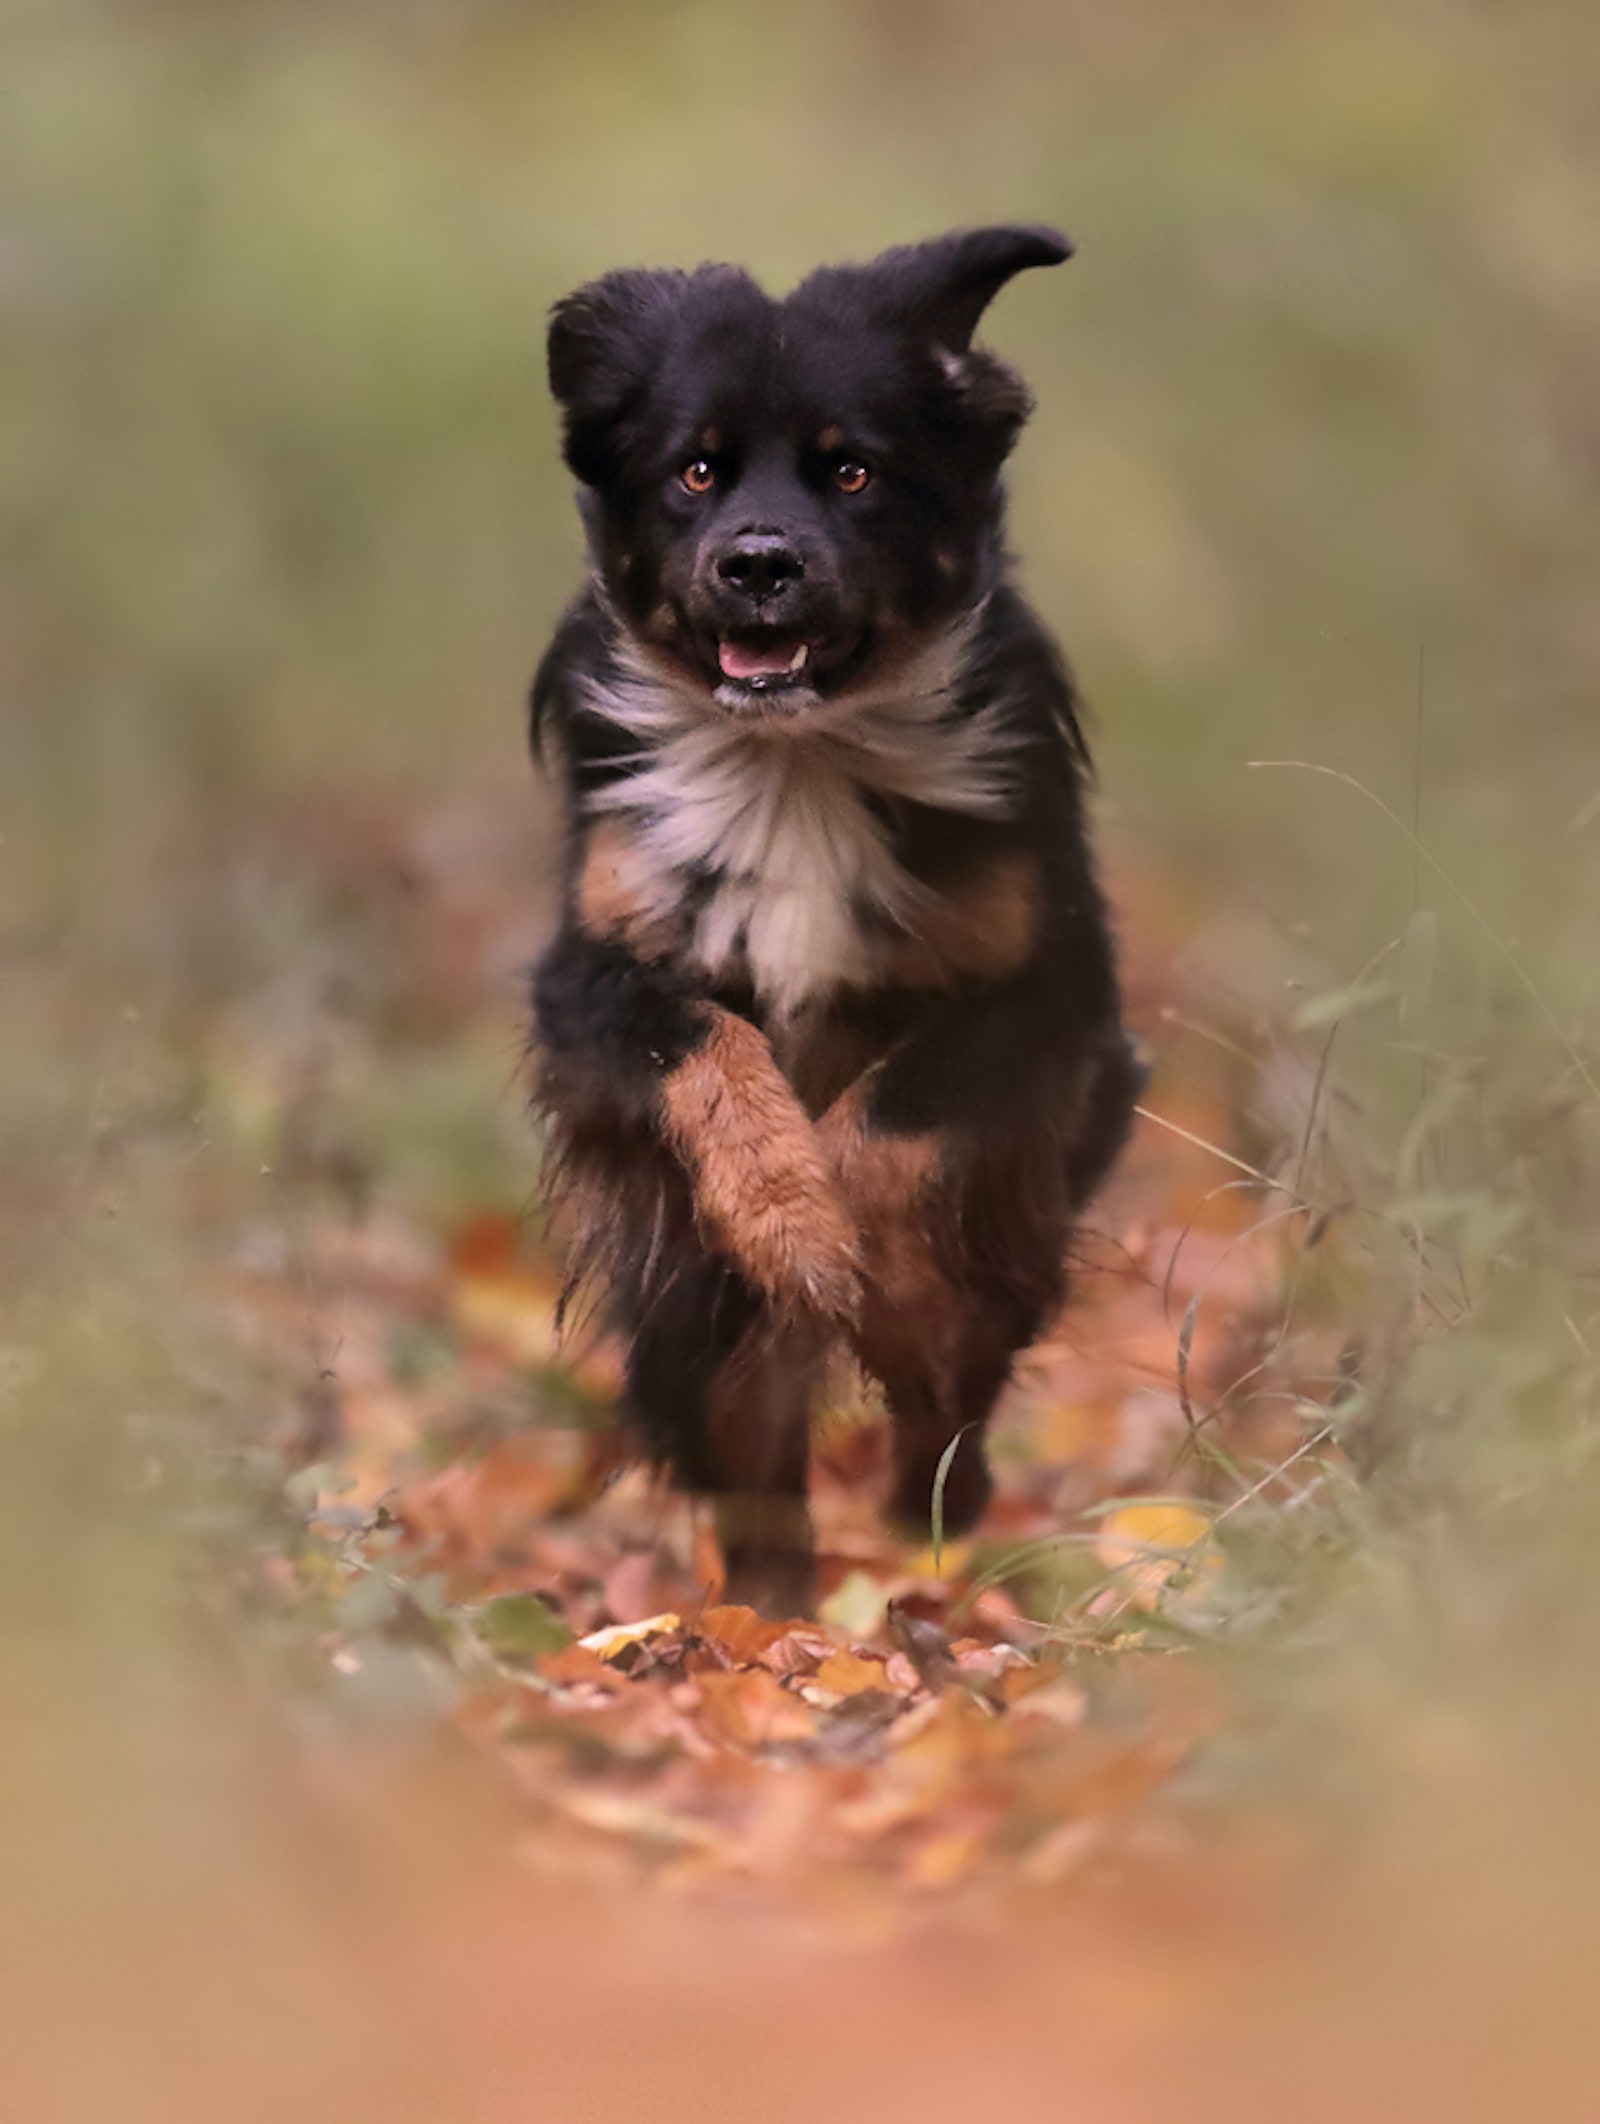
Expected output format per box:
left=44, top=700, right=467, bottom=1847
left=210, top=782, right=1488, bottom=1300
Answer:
left=661, top=1007, right=858, bottom=1321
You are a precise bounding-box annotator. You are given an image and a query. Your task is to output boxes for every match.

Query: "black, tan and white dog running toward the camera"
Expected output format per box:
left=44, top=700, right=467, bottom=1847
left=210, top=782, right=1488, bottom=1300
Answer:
left=533, top=227, right=1141, bottom=1616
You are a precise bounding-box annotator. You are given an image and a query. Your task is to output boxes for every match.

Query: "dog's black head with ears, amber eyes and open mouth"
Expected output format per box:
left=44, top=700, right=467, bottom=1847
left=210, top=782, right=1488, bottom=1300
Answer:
left=550, top=227, right=1069, bottom=718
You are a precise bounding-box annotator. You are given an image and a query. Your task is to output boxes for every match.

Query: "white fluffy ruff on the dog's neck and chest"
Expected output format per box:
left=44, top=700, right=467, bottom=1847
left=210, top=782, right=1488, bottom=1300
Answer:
left=586, top=618, right=1011, bottom=1020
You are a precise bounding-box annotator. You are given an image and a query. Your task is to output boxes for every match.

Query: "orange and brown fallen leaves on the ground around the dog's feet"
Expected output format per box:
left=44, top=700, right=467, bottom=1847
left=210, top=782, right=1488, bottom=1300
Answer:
left=227, top=858, right=1334, bottom=1909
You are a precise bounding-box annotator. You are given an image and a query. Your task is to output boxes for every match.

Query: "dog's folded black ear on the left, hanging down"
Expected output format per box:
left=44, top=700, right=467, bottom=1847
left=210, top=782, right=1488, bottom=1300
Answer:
left=548, top=272, right=688, bottom=486
